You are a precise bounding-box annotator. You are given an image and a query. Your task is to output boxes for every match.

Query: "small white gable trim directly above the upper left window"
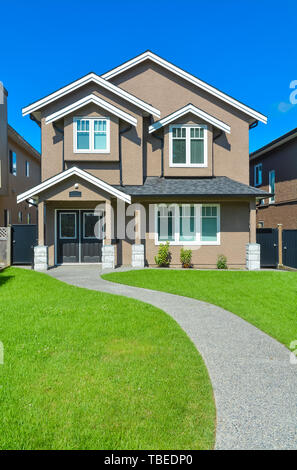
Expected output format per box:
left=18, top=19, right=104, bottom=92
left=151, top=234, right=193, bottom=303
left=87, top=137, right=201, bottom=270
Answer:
left=45, top=93, right=137, bottom=126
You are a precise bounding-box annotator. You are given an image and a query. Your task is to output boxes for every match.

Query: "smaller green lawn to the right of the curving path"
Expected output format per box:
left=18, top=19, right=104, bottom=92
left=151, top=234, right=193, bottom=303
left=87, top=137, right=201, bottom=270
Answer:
left=103, top=269, right=297, bottom=346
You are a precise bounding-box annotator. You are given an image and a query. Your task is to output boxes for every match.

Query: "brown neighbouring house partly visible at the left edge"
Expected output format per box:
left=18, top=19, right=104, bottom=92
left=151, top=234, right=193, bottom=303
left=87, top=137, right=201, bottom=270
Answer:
left=0, top=83, right=40, bottom=227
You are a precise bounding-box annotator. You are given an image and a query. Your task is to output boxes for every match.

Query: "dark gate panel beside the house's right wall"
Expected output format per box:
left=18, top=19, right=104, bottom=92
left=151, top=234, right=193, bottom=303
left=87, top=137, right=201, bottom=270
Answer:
left=257, top=228, right=278, bottom=268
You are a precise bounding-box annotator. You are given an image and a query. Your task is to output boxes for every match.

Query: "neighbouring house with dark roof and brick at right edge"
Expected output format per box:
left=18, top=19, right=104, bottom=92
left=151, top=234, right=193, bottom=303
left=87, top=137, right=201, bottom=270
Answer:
left=250, top=128, right=297, bottom=229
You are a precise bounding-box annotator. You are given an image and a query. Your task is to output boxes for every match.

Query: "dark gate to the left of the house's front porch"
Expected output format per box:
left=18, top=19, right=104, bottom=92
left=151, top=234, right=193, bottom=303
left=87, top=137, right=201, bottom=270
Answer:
left=11, top=224, right=37, bottom=264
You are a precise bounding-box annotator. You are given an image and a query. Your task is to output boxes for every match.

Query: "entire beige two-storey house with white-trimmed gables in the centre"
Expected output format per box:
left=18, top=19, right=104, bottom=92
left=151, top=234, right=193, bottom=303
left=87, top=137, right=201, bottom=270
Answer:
left=18, top=51, right=267, bottom=269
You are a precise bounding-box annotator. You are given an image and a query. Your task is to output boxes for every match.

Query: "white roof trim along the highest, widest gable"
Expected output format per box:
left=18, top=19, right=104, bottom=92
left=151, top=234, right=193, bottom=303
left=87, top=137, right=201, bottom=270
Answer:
left=102, top=51, right=267, bottom=124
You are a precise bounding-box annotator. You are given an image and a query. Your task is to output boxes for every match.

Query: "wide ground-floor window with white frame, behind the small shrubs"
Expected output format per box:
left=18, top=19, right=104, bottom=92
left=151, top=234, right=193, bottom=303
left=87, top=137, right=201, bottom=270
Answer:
left=156, top=204, right=220, bottom=245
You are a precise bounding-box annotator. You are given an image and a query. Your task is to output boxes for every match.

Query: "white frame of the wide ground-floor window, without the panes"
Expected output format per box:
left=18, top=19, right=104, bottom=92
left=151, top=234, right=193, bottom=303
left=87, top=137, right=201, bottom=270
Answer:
left=155, top=203, right=221, bottom=246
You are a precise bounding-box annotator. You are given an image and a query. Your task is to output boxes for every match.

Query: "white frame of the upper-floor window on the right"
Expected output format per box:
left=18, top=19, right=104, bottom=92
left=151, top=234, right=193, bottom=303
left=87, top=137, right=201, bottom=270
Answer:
left=169, top=124, right=208, bottom=168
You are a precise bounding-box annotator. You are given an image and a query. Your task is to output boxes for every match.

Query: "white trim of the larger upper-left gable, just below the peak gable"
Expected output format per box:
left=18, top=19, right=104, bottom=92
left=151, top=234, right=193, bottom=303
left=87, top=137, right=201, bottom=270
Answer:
left=22, top=72, right=161, bottom=117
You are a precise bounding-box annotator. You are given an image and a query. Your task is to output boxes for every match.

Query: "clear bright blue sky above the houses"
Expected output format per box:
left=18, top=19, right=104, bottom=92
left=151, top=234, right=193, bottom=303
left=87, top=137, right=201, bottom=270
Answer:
left=0, top=0, right=297, bottom=151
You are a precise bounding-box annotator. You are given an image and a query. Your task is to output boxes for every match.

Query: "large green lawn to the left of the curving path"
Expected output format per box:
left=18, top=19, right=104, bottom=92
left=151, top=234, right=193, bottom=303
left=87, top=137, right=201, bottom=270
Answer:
left=0, top=268, right=215, bottom=450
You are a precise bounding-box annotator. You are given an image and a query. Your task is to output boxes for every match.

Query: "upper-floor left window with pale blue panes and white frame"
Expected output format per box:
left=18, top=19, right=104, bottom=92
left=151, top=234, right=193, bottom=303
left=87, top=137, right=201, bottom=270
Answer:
left=73, top=118, right=110, bottom=153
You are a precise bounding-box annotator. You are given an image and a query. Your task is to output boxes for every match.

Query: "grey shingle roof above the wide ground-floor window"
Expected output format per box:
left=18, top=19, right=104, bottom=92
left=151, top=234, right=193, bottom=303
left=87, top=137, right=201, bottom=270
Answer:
left=115, top=176, right=270, bottom=198
